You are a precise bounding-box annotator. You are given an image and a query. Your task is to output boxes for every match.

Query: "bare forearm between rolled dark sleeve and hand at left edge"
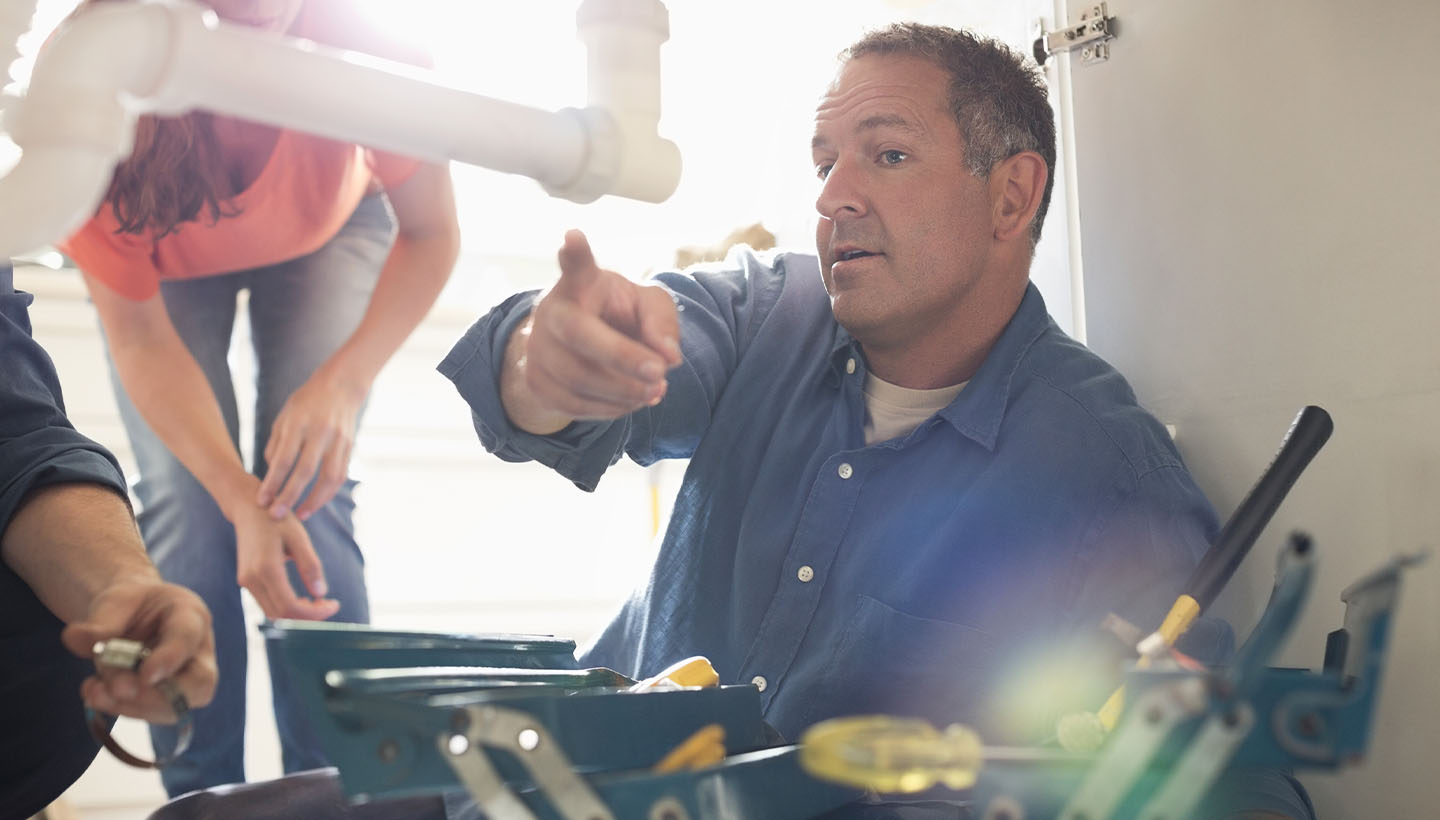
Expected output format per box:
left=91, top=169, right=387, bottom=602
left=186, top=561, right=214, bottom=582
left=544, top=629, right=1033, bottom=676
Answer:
left=0, top=484, right=160, bottom=624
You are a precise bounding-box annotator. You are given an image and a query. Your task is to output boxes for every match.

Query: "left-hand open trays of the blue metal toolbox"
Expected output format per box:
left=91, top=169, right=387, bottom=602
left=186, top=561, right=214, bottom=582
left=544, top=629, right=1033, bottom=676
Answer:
left=262, top=623, right=861, bottom=820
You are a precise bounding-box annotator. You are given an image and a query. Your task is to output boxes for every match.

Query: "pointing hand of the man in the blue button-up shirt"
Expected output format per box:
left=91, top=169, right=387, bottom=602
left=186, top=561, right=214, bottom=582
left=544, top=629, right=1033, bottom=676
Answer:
left=501, top=231, right=681, bottom=435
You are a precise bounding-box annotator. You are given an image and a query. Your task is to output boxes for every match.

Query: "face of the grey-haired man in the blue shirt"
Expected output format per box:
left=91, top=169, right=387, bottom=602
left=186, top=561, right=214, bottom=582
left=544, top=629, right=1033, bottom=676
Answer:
left=812, top=55, right=994, bottom=350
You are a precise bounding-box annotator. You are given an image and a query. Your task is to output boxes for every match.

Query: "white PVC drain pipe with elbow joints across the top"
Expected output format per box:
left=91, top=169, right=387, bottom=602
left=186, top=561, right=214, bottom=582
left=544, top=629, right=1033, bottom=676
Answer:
left=0, top=0, right=680, bottom=258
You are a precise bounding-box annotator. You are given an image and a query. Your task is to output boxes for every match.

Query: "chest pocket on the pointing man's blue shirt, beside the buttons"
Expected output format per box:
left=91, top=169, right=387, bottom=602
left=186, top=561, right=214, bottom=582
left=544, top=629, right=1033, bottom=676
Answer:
left=805, top=595, right=995, bottom=726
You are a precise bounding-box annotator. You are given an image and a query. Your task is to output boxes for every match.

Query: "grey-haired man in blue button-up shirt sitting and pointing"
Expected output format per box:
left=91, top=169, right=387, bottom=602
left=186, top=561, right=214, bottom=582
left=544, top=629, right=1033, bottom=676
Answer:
left=441, top=24, right=1306, bottom=817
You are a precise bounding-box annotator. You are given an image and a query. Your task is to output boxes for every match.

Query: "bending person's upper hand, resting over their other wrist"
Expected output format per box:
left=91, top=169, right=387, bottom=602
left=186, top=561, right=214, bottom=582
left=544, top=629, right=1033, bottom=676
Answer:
left=256, top=367, right=369, bottom=520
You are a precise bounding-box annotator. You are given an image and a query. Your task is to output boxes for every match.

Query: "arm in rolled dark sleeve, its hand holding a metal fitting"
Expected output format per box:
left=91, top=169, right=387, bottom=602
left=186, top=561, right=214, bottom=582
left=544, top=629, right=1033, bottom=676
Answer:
left=0, top=267, right=216, bottom=721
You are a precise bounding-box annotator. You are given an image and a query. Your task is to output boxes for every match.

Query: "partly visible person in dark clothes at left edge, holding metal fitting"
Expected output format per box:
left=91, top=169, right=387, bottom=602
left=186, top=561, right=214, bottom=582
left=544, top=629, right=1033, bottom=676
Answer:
left=0, top=264, right=216, bottom=819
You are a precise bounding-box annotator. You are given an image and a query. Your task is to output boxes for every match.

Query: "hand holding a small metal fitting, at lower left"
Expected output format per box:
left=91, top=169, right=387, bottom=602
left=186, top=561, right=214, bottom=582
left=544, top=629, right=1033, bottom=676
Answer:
left=60, top=578, right=217, bottom=723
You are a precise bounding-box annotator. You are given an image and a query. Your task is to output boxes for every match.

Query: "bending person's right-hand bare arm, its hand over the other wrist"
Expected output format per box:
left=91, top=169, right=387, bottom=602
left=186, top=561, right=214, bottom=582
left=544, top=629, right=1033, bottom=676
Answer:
left=252, top=164, right=459, bottom=519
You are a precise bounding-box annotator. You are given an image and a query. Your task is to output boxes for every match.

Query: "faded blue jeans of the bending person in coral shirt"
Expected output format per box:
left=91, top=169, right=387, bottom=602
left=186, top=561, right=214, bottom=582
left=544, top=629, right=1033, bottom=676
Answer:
left=102, top=195, right=395, bottom=797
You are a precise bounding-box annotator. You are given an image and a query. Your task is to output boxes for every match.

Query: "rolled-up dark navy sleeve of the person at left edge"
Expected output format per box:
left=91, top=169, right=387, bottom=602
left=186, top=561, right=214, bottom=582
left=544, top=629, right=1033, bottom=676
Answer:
left=0, top=265, right=128, bottom=530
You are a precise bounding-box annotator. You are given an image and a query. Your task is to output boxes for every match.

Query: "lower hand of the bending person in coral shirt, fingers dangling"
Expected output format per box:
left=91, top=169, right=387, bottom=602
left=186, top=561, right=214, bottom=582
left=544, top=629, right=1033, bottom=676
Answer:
left=235, top=507, right=340, bottom=621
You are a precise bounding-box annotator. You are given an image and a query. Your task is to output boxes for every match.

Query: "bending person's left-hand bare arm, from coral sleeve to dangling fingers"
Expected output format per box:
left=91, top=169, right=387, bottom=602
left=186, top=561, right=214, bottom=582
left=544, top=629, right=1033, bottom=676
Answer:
left=85, top=274, right=340, bottom=620
